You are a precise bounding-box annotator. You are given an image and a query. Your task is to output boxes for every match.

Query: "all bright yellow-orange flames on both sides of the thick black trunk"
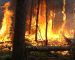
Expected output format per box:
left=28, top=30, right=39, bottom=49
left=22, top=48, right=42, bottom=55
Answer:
left=0, top=0, right=74, bottom=46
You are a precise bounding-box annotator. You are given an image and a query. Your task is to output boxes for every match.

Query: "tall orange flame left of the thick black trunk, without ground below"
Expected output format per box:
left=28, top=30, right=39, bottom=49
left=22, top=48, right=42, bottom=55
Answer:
left=0, top=2, right=13, bottom=42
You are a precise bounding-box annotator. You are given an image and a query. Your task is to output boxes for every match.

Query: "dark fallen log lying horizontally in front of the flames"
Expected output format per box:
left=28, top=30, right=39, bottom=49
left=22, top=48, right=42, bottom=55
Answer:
left=27, top=46, right=72, bottom=52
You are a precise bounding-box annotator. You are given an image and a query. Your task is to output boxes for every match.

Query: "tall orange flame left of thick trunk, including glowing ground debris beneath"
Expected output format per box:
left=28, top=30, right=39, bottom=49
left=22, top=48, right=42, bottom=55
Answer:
left=0, top=2, right=13, bottom=50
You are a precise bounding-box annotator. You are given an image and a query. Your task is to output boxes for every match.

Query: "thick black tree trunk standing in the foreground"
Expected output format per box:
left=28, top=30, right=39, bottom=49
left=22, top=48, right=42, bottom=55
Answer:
left=12, top=0, right=26, bottom=60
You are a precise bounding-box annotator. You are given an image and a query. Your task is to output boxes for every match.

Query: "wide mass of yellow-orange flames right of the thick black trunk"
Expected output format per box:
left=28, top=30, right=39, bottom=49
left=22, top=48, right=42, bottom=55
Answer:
left=25, top=0, right=74, bottom=46
